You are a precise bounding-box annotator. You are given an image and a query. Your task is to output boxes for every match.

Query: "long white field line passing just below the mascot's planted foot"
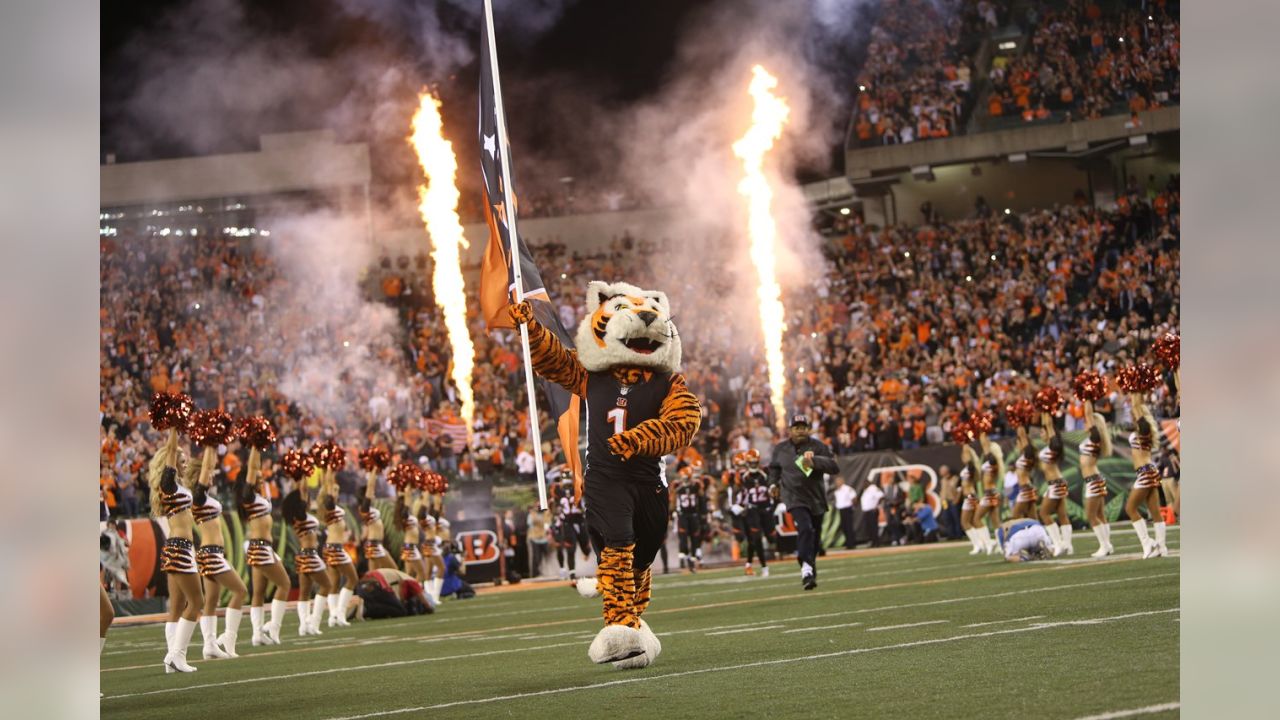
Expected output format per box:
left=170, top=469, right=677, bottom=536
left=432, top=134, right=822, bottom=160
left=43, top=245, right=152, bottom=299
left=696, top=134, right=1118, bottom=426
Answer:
left=317, top=607, right=1179, bottom=720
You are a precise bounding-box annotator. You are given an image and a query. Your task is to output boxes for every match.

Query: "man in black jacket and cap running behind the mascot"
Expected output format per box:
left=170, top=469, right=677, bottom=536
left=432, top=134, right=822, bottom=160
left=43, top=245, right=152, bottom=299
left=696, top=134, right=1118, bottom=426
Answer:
left=769, top=415, right=840, bottom=591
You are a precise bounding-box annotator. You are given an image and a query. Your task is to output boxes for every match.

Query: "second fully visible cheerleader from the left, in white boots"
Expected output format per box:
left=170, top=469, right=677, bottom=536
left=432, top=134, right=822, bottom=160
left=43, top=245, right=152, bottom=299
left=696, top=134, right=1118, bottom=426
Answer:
left=186, top=447, right=248, bottom=660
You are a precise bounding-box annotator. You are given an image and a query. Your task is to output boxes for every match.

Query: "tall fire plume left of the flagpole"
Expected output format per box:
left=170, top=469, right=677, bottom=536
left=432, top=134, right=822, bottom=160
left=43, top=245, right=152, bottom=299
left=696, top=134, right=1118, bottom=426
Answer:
left=408, top=91, right=475, bottom=433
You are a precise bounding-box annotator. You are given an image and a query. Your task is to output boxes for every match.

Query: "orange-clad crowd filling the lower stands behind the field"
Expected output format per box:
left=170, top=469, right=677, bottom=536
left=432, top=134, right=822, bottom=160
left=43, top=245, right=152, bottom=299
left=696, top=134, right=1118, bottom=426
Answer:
left=100, top=177, right=1179, bottom=515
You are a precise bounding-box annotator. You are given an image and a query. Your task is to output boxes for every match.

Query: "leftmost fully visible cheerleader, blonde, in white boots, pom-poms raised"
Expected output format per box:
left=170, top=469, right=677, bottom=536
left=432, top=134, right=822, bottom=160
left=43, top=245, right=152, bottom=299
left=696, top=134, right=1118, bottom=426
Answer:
left=147, top=429, right=202, bottom=673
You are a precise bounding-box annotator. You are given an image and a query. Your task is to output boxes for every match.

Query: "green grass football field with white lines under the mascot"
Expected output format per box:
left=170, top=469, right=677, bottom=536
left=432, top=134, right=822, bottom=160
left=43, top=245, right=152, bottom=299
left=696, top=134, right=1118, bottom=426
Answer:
left=101, top=525, right=1180, bottom=720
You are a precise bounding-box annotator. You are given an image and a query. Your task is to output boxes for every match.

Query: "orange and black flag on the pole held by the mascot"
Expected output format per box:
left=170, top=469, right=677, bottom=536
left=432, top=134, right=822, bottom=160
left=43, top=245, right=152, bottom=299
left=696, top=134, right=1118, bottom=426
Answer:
left=480, top=3, right=582, bottom=492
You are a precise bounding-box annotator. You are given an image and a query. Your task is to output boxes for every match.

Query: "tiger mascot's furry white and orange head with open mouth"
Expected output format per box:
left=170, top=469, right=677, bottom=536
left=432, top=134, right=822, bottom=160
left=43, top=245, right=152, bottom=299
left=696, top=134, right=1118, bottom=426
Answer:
left=575, top=282, right=680, bottom=373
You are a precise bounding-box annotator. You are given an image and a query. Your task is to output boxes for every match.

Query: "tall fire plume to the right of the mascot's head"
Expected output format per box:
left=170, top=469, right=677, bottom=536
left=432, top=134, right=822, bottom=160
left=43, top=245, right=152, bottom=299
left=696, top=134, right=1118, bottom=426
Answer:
left=733, top=65, right=791, bottom=432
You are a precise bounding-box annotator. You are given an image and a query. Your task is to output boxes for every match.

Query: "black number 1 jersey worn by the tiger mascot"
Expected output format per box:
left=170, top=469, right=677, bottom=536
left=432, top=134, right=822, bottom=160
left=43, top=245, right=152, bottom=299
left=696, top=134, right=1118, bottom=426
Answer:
left=586, top=373, right=671, bottom=484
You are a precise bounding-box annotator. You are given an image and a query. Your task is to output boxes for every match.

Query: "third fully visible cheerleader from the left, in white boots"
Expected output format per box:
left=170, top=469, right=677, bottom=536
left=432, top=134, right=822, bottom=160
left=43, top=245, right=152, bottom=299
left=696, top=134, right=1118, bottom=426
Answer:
left=237, top=447, right=293, bottom=647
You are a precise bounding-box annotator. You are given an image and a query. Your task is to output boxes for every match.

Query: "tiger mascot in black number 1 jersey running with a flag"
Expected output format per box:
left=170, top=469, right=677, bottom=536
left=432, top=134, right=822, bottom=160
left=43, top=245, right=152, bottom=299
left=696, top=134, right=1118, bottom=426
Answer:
left=509, top=282, right=701, bottom=669
